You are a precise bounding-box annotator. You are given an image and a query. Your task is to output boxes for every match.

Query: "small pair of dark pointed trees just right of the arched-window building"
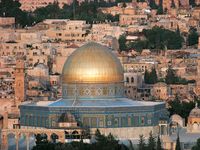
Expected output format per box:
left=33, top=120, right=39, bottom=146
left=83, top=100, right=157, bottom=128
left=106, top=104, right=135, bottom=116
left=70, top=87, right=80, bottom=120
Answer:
left=144, top=68, right=158, bottom=84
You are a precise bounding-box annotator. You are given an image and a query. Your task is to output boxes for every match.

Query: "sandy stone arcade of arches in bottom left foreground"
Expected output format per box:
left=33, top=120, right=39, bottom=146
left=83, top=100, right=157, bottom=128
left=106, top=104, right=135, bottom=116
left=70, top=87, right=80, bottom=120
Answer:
left=1, top=129, right=88, bottom=150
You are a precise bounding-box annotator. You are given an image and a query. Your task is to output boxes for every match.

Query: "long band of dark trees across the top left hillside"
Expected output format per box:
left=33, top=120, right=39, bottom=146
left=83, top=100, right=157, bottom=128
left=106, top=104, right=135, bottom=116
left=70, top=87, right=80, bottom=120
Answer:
left=0, top=0, right=119, bottom=27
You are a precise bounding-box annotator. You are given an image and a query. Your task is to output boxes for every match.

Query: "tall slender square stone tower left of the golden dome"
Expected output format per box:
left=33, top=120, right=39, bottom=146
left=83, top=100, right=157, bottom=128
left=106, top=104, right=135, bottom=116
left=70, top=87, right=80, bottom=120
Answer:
left=15, top=60, right=25, bottom=102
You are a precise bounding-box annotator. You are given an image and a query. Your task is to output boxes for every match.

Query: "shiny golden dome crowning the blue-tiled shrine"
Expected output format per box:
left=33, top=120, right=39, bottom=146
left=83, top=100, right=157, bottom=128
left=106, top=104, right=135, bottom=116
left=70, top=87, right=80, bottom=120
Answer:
left=62, top=42, right=123, bottom=84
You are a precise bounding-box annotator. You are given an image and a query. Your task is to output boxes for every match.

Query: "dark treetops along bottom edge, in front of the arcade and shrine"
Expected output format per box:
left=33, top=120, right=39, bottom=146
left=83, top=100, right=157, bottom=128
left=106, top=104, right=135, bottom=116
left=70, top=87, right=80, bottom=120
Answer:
left=32, top=130, right=128, bottom=150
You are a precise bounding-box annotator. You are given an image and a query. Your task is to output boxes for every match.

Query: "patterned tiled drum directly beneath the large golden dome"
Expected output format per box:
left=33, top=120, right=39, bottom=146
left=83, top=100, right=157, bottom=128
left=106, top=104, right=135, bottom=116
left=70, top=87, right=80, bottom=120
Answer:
left=62, top=83, right=124, bottom=100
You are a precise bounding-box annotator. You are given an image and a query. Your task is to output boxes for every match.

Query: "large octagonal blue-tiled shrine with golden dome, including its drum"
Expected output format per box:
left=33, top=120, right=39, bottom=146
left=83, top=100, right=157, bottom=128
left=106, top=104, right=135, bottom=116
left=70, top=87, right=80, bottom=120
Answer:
left=20, top=42, right=167, bottom=139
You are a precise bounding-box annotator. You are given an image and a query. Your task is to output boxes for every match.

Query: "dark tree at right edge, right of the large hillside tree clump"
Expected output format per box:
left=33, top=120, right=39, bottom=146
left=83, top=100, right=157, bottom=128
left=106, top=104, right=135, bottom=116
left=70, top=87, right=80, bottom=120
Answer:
left=187, top=28, right=199, bottom=46
